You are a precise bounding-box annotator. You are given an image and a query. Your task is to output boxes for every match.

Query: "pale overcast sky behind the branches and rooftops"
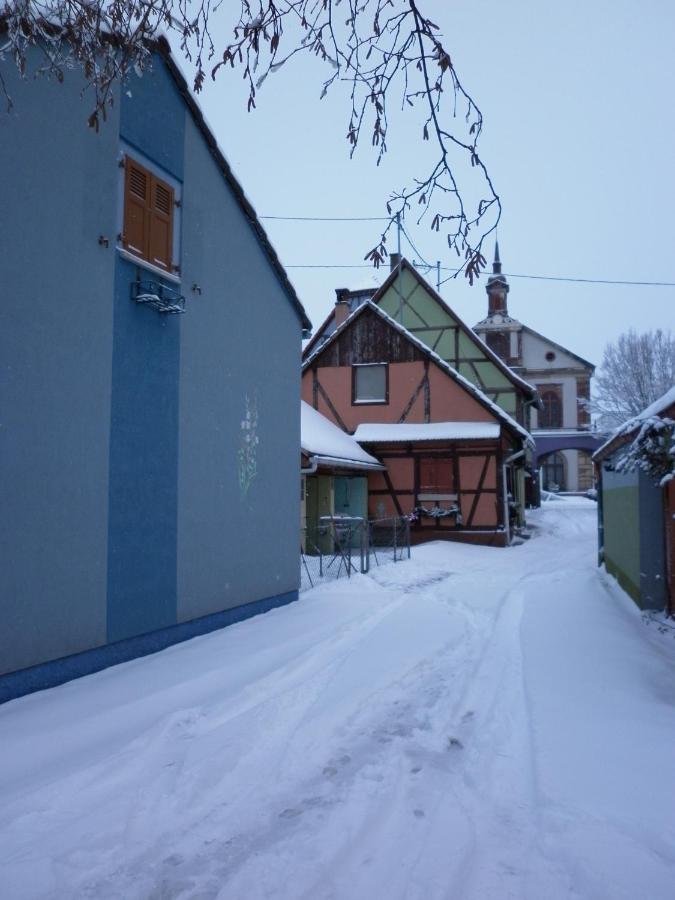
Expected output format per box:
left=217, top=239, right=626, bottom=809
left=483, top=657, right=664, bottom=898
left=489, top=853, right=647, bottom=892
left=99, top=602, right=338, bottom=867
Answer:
left=195, top=0, right=675, bottom=364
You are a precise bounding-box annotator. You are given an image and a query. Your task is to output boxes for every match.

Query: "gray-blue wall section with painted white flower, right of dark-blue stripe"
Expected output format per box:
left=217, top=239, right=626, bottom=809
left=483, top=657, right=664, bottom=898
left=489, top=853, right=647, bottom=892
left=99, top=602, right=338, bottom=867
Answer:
left=178, top=117, right=301, bottom=621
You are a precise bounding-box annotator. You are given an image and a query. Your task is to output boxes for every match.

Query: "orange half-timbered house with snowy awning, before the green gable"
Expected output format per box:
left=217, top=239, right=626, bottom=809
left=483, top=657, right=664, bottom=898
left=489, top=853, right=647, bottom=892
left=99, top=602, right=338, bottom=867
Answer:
left=302, top=298, right=532, bottom=545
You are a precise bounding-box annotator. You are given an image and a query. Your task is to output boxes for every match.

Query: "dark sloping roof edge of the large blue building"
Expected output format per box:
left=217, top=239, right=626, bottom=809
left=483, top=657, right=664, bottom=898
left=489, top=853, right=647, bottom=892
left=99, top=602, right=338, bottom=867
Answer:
left=152, top=37, right=312, bottom=331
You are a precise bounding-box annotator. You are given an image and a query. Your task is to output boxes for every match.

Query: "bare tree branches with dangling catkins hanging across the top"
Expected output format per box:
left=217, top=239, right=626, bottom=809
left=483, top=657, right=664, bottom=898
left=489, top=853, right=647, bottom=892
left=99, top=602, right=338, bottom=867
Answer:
left=0, top=0, right=501, bottom=283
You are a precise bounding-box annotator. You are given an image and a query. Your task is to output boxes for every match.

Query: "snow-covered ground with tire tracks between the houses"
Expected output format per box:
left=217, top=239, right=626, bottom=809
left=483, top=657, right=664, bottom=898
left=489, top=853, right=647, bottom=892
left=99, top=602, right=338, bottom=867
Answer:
left=0, top=499, right=675, bottom=900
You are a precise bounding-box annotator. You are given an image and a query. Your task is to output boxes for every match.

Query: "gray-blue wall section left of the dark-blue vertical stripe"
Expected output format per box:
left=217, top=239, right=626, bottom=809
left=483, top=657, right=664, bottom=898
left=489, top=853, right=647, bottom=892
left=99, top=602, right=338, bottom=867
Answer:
left=0, top=65, right=119, bottom=673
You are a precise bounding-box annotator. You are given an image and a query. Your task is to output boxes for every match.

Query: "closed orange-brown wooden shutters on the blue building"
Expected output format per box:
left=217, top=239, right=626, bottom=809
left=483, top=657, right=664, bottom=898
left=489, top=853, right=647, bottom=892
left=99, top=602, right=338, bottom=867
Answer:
left=122, top=156, right=174, bottom=272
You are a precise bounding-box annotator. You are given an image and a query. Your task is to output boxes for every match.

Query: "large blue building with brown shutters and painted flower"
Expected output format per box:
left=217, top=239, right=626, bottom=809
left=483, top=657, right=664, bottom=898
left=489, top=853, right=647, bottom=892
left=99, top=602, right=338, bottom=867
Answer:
left=0, top=41, right=310, bottom=700
